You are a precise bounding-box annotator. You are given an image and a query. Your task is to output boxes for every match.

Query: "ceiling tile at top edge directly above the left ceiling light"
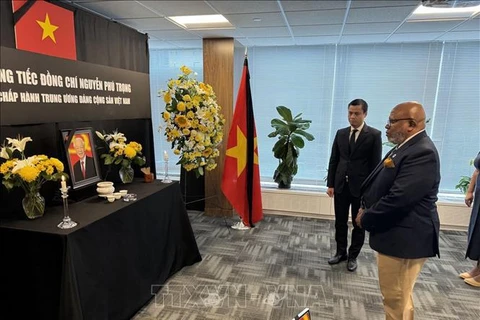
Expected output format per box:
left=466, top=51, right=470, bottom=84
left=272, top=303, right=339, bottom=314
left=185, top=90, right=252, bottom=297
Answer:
left=140, top=0, right=217, bottom=17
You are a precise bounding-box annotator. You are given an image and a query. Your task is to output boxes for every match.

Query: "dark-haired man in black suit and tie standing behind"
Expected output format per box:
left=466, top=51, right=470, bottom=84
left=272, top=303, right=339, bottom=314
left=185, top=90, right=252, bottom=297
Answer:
left=327, top=99, right=382, bottom=271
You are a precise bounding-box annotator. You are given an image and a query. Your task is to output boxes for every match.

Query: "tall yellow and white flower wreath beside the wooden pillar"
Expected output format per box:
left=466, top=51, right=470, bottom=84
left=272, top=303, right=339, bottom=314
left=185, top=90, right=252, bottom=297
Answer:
left=159, top=66, right=225, bottom=177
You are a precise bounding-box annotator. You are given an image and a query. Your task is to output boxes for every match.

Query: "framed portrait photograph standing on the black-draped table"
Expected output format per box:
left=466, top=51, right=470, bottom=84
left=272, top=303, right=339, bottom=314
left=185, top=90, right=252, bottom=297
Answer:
left=62, top=128, right=102, bottom=189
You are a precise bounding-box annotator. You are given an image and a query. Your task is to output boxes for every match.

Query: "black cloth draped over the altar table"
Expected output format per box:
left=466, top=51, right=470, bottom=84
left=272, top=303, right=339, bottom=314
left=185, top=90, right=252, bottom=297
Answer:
left=0, top=181, right=201, bottom=320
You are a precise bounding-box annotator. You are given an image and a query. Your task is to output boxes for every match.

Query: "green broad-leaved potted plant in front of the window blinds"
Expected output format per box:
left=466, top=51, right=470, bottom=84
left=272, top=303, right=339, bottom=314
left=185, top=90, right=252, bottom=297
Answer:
left=268, top=106, right=315, bottom=189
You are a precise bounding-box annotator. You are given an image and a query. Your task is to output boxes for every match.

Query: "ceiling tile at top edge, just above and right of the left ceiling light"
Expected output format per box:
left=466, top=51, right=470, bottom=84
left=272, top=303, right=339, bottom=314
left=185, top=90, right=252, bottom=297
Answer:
left=208, top=1, right=280, bottom=15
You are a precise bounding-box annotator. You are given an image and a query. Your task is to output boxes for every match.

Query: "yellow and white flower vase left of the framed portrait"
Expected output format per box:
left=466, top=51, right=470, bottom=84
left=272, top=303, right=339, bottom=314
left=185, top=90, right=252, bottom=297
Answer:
left=0, top=137, right=66, bottom=219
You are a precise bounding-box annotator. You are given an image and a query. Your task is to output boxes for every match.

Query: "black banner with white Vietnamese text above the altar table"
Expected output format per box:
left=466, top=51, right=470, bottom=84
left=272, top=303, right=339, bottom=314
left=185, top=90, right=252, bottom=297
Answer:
left=0, top=47, right=151, bottom=125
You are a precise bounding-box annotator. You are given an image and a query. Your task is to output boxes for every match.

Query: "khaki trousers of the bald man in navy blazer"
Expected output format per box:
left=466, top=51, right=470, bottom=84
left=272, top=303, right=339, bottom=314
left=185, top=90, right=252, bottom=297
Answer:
left=377, top=253, right=427, bottom=320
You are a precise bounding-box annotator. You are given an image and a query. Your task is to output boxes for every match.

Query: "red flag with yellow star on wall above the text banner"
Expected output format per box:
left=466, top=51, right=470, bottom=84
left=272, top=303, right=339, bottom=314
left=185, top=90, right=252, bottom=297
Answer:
left=12, top=0, right=77, bottom=60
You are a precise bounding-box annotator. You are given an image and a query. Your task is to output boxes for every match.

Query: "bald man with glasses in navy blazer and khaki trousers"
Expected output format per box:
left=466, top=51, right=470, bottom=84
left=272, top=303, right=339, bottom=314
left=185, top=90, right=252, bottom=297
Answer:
left=357, top=102, right=440, bottom=320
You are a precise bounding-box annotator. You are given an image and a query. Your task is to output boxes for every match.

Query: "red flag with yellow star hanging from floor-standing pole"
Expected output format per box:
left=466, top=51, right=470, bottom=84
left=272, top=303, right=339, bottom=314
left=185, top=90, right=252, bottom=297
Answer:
left=222, top=57, right=263, bottom=227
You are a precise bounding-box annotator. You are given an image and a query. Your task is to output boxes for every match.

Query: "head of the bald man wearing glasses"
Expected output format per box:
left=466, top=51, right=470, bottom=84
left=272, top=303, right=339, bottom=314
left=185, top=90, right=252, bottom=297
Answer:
left=385, top=101, right=425, bottom=144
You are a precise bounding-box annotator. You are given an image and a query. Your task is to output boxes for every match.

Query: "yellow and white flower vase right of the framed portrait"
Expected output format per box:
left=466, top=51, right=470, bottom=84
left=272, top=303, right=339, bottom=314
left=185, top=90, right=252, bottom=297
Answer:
left=95, top=130, right=145, bottom=183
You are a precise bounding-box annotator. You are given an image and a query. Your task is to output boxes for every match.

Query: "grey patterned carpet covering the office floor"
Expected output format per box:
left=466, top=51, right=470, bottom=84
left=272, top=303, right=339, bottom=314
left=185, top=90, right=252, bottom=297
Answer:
left=133, top=212, right=480, bottom=320
